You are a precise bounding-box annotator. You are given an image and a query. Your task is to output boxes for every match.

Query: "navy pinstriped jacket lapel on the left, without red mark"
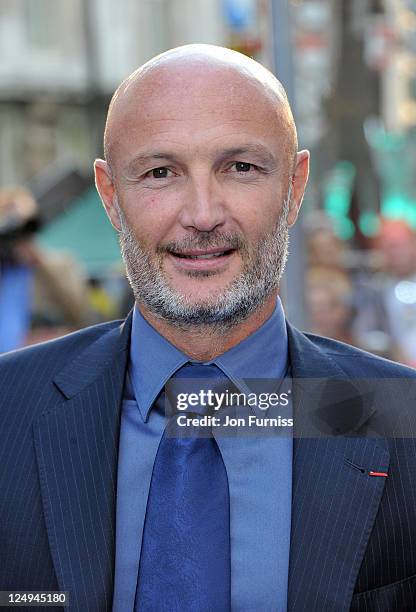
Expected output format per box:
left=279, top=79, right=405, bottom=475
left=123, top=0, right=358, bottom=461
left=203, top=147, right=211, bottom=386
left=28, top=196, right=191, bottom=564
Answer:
left=34, top=317, right=131, bottom=612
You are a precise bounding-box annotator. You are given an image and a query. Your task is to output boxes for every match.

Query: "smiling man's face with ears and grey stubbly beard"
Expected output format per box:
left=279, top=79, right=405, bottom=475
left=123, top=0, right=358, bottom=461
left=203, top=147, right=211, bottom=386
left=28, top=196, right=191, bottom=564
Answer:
left=96, top=64, right=307, bottom=327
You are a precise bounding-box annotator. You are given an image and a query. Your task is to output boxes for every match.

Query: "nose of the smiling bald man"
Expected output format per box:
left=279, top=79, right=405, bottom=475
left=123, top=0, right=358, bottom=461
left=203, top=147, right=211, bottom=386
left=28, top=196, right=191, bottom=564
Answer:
left=180, top=175, right=226, bottom=232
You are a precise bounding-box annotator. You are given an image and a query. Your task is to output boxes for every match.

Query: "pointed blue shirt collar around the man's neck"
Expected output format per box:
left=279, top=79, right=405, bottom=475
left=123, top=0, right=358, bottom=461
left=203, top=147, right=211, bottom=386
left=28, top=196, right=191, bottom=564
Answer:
left=129, top=298, right=288, bottom=421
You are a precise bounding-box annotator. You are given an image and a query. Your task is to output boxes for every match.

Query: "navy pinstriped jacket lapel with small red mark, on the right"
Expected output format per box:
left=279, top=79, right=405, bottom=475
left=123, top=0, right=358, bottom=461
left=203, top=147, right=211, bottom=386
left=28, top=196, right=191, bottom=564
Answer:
left=288, top=327, right=389, bottom=612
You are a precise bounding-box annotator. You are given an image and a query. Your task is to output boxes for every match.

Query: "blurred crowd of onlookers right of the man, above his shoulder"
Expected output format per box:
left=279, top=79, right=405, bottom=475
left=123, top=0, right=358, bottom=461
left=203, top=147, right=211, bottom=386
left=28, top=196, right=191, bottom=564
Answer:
left=306, top=214, right=416, bottom=367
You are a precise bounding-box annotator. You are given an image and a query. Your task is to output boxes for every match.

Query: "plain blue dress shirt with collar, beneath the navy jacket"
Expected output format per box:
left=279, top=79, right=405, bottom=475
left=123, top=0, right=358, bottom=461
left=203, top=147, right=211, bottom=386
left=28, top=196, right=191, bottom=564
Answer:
left=113, top=299, right=293, bottom=612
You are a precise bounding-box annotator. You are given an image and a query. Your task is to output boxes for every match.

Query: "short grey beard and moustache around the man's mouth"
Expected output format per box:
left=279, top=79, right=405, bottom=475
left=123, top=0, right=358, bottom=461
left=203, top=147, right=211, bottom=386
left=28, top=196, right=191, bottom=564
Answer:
left=116, top=194, right=291, bottom=333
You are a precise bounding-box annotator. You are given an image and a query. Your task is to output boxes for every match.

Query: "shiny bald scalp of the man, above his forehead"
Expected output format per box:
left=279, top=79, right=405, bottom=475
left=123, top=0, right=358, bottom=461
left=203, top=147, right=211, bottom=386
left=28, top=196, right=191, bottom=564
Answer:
left=104, top=45, right=298, bottom=168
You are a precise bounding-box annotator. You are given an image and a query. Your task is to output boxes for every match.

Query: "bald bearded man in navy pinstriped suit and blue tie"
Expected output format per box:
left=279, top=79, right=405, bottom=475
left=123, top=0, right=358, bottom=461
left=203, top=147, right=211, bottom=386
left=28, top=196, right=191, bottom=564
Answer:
left=0, top=45, right=416, bottom=612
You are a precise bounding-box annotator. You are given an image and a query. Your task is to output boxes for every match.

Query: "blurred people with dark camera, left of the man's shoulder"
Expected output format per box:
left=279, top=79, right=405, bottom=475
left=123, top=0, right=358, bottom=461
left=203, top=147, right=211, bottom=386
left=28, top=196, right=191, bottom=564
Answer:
left=0, top=187, right=131, bottom=353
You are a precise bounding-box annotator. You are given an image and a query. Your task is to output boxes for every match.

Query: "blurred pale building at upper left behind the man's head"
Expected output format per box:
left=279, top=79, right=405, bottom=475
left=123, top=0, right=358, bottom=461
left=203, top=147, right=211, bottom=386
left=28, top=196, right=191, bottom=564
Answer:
left=0, top=0, right=226, bottom=185
